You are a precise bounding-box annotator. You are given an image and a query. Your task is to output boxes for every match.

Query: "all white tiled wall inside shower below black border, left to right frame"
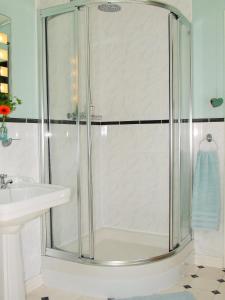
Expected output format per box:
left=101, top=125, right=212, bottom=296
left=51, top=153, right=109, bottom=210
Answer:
left=46, top=124, right=169, bottom=247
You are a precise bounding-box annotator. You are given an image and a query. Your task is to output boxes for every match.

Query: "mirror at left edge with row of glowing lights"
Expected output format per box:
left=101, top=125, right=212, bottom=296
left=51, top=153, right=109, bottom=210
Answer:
left=0, top=15, right=11, bottom=94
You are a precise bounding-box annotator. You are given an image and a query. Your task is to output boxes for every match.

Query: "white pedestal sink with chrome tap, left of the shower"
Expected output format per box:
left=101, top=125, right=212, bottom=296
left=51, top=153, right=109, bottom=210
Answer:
left=0, top=182, right=70, bottom=300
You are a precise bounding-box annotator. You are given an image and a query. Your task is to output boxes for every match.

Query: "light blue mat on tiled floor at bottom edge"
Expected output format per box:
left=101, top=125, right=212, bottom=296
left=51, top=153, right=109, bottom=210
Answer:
left=110, top=292, right=195, bottom=300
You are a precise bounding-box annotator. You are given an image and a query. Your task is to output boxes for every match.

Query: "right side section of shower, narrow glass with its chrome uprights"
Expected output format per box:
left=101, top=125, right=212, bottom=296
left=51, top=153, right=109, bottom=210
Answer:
left=170, top=15, right=192, bottom=249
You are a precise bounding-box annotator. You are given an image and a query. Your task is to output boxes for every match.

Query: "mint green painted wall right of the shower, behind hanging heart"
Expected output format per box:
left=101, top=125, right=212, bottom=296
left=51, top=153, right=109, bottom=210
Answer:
left=193, top=0, right=225, bottom=118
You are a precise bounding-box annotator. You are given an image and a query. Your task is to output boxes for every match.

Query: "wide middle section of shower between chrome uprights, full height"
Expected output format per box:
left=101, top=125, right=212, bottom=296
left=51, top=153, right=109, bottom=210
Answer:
left=89, top=3, right=169, bottom=261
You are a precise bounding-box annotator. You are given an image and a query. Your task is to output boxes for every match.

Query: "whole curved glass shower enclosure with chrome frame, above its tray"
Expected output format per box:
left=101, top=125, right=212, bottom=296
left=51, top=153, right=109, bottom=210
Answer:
left=41, top=1, right=192, bottom=266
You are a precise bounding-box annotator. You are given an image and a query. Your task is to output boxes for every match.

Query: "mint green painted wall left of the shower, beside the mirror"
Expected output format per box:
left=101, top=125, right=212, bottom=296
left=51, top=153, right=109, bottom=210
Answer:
left=0, top=0, right=38, bottom=118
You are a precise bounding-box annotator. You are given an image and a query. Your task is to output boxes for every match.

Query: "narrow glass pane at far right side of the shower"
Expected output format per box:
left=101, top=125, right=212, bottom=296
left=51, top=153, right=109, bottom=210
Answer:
left=179, top=23, right=192, bottom=241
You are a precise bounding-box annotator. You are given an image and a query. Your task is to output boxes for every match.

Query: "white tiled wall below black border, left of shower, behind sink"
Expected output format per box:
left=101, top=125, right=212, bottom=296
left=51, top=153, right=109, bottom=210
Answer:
left=0, top=123, right=41, bottom=279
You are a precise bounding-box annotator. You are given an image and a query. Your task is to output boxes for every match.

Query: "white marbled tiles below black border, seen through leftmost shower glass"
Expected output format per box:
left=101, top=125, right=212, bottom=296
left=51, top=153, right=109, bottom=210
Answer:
left=49, top=124, right=78, bottom=247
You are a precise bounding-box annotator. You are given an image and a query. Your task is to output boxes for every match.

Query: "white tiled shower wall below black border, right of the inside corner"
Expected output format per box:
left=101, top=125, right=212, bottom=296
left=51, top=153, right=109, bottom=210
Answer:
left=99, top=124, right=169, bottom=235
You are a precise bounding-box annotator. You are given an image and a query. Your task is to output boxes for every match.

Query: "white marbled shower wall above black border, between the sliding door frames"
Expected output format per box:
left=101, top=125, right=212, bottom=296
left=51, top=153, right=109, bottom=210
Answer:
left=90, top=4, right=169, bottom=121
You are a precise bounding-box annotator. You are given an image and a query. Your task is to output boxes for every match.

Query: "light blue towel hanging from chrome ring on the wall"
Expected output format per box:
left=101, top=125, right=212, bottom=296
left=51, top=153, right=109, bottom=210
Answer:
left=192, top=151, right=220, bottom=230
